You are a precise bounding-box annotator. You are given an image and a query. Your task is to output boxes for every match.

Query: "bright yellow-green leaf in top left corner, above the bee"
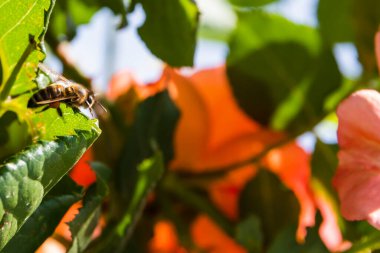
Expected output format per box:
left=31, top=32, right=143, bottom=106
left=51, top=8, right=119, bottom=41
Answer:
left=0, top=0, right=52, bottom=98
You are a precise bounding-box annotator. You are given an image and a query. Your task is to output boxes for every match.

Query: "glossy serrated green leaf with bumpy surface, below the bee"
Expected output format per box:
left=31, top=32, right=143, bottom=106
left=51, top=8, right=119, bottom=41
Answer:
left=0, top=130, right=99, bottom=250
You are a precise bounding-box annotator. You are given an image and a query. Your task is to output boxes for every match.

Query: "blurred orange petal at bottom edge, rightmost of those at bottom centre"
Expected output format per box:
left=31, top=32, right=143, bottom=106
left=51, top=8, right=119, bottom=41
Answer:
left=191, top=215, right=247, bottom=253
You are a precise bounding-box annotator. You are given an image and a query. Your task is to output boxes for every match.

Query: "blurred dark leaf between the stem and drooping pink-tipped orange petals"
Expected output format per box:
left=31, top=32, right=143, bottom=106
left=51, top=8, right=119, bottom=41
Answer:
left=239, top=169, right=299, bottom=247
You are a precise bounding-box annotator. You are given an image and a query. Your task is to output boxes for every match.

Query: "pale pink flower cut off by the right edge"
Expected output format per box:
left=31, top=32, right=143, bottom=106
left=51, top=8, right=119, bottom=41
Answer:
left=333, top=90, right=380, bottom=229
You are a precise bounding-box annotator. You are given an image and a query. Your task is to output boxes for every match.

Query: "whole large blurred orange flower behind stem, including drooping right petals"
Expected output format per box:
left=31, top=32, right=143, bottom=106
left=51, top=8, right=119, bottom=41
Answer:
left=168, top=67, right=349, bottom=251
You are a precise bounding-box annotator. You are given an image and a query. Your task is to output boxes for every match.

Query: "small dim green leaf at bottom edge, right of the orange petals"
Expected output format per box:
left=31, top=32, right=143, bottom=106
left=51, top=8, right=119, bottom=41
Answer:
left=235, top=215, right=263, bottom=252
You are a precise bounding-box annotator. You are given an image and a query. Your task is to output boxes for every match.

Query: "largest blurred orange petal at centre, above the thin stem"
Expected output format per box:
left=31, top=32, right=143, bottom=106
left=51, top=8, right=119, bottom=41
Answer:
left=169, top=67, right=283, bottom=172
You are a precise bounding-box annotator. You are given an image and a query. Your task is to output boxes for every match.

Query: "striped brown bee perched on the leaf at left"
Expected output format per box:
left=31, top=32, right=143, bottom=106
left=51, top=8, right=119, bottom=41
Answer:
left=28, top=64, right=106, bottom=116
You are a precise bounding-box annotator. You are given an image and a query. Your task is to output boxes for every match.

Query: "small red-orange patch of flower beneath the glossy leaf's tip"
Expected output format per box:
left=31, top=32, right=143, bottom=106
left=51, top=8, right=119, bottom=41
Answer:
left=70, top=149, right=96, bottom=187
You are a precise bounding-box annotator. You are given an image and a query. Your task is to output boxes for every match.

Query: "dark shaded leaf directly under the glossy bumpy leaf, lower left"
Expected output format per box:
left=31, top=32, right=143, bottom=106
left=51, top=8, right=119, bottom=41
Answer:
left=2, top=176, right=82, bottom=253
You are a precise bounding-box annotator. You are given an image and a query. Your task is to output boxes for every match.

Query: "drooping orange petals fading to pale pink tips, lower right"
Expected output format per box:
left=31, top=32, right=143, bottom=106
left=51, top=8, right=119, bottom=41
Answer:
left=264, top=143, right=351, bottom=251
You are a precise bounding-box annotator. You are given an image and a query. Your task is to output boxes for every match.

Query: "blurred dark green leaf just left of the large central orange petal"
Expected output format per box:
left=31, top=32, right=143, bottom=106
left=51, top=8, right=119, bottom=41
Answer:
left=115, top=91, right=179, bottom=203
